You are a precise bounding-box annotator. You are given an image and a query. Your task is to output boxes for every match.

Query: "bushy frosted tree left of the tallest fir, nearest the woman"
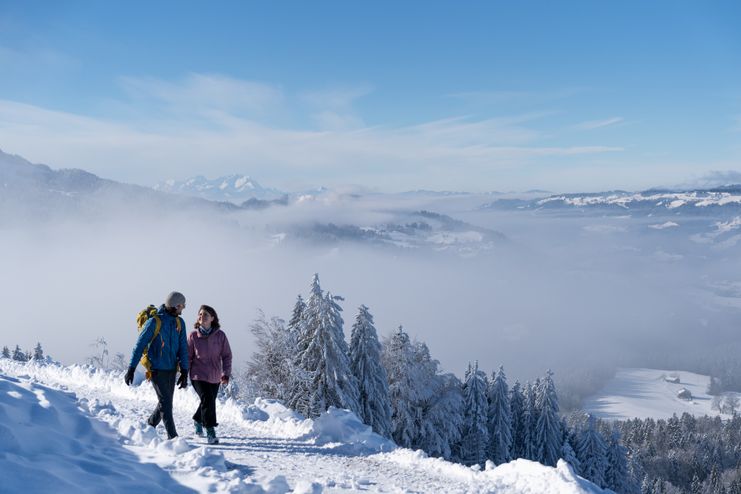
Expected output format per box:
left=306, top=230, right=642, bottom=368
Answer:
left=246, top=311, right=296, bottom=400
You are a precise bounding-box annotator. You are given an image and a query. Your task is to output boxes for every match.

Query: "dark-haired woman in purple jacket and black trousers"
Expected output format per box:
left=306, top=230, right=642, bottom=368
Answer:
left=188, top=305, right=232, bottom=444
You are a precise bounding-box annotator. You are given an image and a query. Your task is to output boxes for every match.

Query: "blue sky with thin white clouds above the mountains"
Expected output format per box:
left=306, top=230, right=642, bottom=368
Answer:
left=0, top=0, right=741, bottom=191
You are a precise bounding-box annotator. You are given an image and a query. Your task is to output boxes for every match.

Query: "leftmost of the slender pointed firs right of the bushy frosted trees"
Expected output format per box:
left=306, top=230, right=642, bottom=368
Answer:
left=458, top=361, right=489, bottom=465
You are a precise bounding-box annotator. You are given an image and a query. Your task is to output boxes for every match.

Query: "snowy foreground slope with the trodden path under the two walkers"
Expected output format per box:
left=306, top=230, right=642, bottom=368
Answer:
left=0, top=359, right=603, bottom=494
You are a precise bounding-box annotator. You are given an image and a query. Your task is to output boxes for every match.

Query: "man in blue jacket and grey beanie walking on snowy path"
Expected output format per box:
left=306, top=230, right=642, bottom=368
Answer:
left=124, top=292, right=188, bottom=439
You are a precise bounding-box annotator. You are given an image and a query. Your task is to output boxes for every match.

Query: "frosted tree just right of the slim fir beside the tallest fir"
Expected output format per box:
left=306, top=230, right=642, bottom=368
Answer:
left=381, top=326, right=419, bottom=448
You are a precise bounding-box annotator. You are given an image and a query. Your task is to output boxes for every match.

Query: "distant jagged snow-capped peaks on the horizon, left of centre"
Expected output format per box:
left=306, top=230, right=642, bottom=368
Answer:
left=153, top=175, right=285, bottom=204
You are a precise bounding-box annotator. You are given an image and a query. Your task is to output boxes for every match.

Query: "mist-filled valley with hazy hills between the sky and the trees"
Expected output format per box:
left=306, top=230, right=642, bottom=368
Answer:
left=0, top=149, right=741, bottom=392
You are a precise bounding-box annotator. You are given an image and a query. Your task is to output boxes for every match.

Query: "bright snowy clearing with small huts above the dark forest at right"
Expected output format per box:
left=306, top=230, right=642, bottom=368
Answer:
left=584, top=368, right=728, bottom=420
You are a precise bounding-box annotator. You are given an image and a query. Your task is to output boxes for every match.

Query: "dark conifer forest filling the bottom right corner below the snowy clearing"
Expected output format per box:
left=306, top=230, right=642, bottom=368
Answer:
left=615, top=413, right=741, bottom=494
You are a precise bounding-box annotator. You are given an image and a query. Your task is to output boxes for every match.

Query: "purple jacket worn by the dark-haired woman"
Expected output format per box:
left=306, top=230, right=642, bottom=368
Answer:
left=188, top=329, right=232, bottom=384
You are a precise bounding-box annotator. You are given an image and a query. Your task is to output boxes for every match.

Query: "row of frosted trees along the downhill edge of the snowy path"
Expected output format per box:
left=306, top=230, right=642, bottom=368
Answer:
left=242, top=275, right=640, bottom=494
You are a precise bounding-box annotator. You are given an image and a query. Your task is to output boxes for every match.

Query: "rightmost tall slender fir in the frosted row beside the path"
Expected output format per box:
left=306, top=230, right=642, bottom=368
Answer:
left=534, top=370, right=563, bottom=467
